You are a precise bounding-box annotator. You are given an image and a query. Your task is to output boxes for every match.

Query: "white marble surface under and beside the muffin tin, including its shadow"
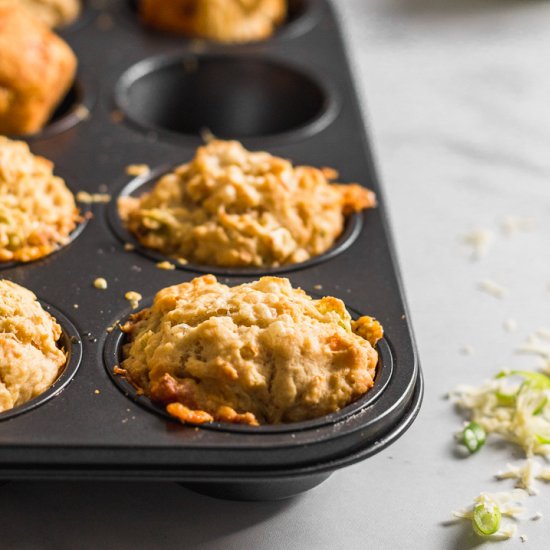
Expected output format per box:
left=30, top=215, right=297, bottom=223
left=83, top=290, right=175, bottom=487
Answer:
left=0, top=0, right=550, bottom=550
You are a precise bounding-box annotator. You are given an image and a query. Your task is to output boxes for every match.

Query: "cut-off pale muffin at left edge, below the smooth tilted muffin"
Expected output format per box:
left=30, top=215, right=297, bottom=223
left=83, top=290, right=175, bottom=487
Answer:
left=0, top=136, right=80, bottom=265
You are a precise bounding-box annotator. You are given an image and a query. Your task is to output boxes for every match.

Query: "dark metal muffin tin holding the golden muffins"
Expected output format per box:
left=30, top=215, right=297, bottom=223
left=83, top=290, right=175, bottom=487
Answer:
left=0, top=0, right=422, bottom=499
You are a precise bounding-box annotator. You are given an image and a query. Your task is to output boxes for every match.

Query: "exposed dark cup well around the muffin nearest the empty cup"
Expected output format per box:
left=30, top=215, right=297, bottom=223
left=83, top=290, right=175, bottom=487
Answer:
left=107, top=166, right=363, bottom=277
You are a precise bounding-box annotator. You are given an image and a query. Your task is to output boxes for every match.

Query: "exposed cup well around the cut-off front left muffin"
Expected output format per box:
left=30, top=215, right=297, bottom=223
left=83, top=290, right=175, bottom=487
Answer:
left=0, top=300, right=82, bottom=422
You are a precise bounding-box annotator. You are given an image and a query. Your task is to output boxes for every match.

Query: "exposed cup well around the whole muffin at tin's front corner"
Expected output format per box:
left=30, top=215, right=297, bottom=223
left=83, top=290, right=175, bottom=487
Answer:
left=103, top=298, right=393, bottom=434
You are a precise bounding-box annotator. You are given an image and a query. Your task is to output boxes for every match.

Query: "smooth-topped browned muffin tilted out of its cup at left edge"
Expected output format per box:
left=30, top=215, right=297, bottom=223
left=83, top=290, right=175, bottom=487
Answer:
left=0, top=2, right=76, bottom=135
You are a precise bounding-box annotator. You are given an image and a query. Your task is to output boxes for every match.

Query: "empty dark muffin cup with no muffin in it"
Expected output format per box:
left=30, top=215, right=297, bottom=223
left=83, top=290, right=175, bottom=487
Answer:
left=115, top=53, right=339, bottom=141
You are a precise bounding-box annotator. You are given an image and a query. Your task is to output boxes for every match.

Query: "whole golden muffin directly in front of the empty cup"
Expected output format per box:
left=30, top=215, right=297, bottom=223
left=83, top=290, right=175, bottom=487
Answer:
left=119, top=140, right=376, bottom=267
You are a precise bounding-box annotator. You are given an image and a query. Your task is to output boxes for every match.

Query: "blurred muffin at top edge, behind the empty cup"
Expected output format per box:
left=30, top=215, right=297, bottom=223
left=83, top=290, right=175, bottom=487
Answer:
left=138, top=0, right=287, bottom=42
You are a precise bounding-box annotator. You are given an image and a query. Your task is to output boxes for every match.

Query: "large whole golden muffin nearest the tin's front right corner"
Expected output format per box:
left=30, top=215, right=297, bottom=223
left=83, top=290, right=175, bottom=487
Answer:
left=121, top=275, right=383, bottom=425
